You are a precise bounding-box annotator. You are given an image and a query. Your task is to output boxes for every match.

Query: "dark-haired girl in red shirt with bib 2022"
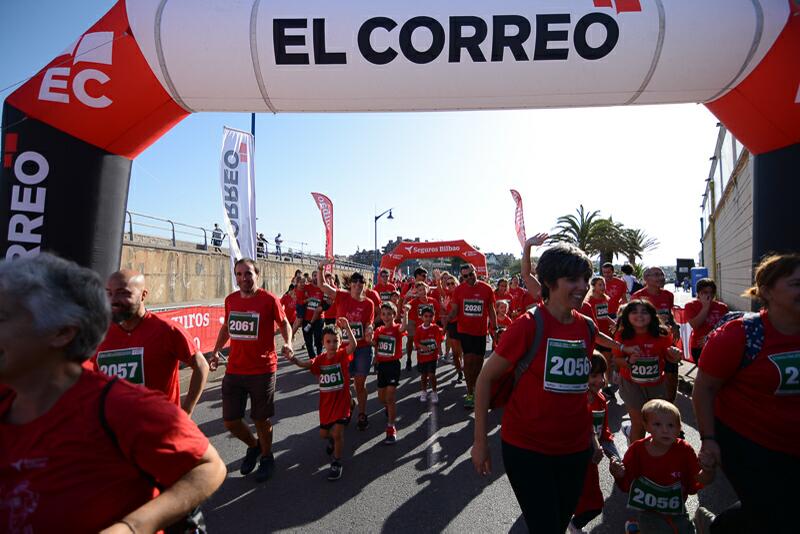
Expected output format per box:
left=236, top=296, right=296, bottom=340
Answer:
left=614, top=300, right=681, bottom=443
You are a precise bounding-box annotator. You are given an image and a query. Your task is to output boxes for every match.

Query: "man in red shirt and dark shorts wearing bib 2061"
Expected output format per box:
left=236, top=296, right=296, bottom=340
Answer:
left=211, top=258, right=294, bottom=482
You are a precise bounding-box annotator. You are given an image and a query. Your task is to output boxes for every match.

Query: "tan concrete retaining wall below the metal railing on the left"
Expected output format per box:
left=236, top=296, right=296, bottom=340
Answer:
left=120, top=241, right=371, bottom=306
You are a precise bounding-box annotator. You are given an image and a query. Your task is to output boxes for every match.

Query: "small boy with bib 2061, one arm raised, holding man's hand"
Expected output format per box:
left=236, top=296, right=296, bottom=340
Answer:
left=289, top=317, right=357, bottom=481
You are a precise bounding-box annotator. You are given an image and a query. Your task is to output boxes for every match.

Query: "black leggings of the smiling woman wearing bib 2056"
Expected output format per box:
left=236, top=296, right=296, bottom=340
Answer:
left=502, top=441, right=592, bottom=534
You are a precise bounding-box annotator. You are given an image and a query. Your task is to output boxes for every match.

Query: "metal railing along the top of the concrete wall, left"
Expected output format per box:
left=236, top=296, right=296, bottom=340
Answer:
left=124, top=211, right=372, bottom=273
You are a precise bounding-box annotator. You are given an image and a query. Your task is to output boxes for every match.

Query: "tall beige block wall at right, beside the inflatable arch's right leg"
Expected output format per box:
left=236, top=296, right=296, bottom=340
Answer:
left=703, top=153, right=753, bottom=310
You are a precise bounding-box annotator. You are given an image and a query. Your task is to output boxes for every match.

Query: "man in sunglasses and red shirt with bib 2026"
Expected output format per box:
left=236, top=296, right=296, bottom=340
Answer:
left=447, top=264, right=497, bottom=409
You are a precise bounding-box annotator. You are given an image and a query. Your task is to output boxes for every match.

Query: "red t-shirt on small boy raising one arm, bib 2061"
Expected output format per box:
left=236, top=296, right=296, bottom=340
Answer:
left=311, top=347, right=353, bottom=425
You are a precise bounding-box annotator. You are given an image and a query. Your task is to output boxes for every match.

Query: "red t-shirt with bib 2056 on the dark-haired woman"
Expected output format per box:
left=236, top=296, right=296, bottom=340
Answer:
left=496, top=307, right=594, bottom=454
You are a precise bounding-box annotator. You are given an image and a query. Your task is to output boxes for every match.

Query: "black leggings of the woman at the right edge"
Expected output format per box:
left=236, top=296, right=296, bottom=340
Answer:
left=711, top=419, right=800, bottom=534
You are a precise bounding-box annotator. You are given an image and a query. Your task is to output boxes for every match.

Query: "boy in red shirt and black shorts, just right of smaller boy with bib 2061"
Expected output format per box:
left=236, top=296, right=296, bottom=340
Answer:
left=372, top=302, right=408, bottom=445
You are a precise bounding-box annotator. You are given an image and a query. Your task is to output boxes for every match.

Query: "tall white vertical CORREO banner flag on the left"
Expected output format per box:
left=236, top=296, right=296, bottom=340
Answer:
left=219, top=126, right=256, bottom=288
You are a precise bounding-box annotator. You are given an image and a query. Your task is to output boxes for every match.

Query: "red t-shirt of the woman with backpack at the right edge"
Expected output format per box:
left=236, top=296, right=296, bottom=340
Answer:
left=700, top=311, right=800, bottom=457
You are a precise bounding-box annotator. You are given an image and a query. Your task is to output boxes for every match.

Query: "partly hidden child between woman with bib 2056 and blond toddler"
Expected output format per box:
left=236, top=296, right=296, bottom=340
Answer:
left=568, top=351, right=620, bottom=534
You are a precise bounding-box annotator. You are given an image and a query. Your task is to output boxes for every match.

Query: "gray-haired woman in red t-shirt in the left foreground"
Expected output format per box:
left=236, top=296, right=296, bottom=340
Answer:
left=0, top=253, right=225, bottom=534
